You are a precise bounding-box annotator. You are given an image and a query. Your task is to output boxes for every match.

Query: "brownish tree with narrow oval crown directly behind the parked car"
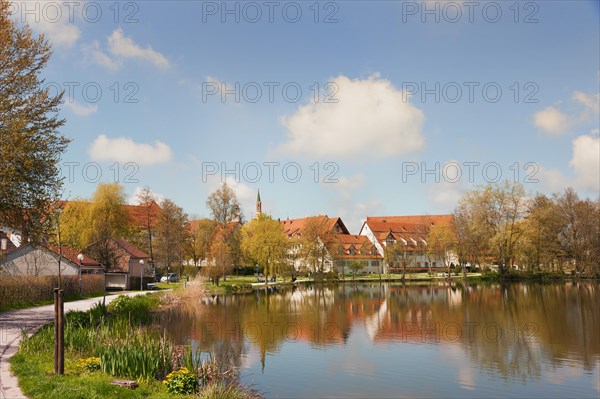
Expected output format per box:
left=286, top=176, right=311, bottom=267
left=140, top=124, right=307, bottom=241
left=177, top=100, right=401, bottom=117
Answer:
left=155, top=199, right=189, bottom=274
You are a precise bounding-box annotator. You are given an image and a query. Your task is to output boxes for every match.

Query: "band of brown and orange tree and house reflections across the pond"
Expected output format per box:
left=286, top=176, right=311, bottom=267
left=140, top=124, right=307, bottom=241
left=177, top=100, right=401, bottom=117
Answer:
left=157, top=281, right=600, bottom=381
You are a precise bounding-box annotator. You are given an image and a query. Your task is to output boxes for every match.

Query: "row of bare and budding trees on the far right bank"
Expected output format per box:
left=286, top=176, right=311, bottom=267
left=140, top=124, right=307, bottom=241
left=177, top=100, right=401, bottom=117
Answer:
left=452, top=182, right=600, bottom=273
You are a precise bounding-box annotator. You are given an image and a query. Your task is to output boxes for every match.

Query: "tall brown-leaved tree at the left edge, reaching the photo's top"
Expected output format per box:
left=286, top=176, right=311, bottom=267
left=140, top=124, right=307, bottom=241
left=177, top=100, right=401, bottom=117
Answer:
left=0, top=0, right=69, bottom=241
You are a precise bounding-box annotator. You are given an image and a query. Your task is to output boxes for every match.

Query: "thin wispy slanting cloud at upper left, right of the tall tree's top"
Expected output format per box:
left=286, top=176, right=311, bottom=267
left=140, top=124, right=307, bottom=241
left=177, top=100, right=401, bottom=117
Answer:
left=84, top=28, right=171, bottom=70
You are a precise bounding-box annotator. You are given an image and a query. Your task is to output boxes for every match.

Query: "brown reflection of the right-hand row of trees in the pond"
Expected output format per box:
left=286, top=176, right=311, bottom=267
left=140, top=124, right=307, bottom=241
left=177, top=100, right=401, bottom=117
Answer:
left=463, top=283, right=600, bottom=382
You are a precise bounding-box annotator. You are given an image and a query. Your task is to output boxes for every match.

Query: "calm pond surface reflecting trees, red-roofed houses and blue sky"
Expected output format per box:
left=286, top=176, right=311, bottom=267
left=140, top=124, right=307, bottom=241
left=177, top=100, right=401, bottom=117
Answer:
left=163, top=282, right=600, bottom=398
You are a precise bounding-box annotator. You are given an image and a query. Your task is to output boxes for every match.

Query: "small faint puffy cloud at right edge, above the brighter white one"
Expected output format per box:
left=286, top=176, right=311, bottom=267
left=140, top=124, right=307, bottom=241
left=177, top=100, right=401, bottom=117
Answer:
left=533, top=91, right=600, bottom=136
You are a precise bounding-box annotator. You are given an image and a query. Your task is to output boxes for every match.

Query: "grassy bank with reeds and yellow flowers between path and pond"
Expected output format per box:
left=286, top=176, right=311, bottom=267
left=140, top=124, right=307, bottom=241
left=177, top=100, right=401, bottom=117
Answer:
left=11, top=295, right=256, bottom=399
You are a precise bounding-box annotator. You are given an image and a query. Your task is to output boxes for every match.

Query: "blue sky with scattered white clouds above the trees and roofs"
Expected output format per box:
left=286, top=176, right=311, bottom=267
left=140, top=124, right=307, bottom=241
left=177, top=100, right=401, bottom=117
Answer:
left=13, top=1, right=600, bottom=233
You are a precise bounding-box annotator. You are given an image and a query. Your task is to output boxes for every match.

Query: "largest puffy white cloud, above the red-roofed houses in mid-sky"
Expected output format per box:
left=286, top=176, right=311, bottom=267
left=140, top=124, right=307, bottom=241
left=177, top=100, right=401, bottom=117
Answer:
left=277, top=75, right=425, bottom=159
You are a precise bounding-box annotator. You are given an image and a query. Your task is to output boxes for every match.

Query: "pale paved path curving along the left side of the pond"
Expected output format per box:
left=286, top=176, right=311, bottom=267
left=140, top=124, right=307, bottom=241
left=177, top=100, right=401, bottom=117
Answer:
left=0, top=291, right=148, bottom=399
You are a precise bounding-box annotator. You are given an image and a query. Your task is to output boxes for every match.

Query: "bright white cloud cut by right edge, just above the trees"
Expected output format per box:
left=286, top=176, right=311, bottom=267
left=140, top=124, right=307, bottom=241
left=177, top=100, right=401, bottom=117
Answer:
left=569, top=135, right=600, bottom=192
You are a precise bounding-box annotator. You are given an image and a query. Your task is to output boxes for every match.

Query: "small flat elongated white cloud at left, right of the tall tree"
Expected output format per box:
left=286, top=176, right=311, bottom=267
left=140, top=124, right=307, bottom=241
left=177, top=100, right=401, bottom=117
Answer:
left=88, top=134, right=172, bottom=165
